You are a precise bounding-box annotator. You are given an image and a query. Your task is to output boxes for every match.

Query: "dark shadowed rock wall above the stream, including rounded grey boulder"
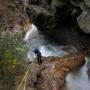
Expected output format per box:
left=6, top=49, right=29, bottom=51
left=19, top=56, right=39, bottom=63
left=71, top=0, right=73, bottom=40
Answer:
left=25, top=0, right=90, bottom=49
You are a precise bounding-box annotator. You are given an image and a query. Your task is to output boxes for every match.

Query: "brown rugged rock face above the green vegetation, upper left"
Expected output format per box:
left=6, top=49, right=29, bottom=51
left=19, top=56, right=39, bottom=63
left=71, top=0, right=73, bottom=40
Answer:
left=0, top=0, right=28, bottom=31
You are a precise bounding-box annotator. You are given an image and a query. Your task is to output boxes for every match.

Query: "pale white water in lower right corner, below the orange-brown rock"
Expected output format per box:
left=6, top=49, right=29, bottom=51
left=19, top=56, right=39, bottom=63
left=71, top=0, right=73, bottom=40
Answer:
left=66, top=58, right=90, bottom=90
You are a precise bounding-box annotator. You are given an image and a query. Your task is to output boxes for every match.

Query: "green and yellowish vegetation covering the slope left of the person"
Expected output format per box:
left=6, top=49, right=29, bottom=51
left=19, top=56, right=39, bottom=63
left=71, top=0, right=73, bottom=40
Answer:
left=0, top=31, right=27, bottom=90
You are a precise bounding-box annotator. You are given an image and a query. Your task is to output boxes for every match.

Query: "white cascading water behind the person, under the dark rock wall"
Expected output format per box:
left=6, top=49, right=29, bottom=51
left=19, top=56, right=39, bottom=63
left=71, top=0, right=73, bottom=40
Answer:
left=24, top=24, right=77, bottom=61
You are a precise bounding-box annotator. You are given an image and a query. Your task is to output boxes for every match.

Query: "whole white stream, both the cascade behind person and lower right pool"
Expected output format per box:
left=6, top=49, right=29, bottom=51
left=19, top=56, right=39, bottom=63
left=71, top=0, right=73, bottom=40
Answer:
left=24, top=24, right=90, bottom=90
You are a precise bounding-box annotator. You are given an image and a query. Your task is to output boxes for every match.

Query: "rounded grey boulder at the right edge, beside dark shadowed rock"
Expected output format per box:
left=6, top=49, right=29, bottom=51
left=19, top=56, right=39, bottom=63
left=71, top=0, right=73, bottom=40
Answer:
left=77, top=10, right=90, bottom=34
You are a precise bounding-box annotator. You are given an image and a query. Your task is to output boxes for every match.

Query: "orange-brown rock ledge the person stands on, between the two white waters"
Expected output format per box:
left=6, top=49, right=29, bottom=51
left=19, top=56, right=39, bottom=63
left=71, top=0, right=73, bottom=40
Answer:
left=27, top=53, right=85, bottom=90
